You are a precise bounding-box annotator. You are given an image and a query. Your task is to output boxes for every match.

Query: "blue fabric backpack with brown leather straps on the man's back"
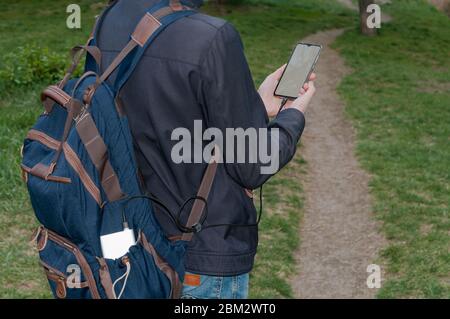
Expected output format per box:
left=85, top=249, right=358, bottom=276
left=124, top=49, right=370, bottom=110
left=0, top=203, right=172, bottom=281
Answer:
left=21, top=0, right=217, bottom=299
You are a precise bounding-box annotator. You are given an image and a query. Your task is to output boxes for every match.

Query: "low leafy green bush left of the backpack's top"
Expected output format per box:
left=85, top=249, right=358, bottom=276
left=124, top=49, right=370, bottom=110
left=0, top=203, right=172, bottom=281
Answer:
left=0, top=45, right=69, bottom=90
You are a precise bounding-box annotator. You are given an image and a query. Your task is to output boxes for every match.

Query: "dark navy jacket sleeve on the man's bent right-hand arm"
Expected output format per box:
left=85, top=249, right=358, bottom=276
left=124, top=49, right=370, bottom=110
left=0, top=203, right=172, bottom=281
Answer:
left=199, top=23, right=305, bottom=189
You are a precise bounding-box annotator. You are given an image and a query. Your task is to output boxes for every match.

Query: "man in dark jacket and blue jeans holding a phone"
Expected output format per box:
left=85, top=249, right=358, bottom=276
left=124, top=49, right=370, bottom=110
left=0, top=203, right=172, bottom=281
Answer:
left=97, top=0, right=315, bottom=298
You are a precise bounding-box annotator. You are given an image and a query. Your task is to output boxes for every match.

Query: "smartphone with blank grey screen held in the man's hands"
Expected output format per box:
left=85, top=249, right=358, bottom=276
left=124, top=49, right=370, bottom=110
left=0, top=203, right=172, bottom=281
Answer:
left=274, top=43, right=322, bottom=99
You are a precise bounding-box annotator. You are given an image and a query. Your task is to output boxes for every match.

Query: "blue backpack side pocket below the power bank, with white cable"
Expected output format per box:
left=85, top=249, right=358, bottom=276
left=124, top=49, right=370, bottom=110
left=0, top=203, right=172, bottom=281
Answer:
left=99, top=232, right=182, bottom=299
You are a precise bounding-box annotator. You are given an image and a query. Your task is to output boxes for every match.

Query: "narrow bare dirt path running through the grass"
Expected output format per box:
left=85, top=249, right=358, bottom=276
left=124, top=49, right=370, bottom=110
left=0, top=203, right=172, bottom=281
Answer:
left=293, top=30, right=383, bottom=298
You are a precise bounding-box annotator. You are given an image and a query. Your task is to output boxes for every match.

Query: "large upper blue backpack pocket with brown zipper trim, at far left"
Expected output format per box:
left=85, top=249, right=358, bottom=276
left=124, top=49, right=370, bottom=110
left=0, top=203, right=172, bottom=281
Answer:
left=21, top=129, right=102, bottom=238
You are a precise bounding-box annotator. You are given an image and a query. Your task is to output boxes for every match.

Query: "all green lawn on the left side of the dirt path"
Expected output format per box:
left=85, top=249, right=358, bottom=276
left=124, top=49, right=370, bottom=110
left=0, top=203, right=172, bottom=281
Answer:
left=0, top=0, right=355, bottom=298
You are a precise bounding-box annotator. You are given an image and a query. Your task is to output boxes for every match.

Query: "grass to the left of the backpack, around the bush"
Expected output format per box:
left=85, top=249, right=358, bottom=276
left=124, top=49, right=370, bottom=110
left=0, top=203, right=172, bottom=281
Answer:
left=0, top=0, right=103, bottom=298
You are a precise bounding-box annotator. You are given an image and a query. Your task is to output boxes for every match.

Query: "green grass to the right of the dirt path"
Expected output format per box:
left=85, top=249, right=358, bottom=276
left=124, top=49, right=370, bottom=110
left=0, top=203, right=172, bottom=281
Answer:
left=336, top=0, right=450, bottom=298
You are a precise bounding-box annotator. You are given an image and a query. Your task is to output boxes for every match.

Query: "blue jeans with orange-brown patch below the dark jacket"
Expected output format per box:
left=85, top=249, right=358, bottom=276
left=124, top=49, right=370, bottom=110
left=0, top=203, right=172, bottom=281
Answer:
left=181, top=273, right=249, bottom=299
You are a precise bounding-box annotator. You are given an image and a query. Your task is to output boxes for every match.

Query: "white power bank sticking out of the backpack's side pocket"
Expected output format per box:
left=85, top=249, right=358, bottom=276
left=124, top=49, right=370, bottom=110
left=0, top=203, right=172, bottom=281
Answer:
left=100, top=228, right=136, bottom=259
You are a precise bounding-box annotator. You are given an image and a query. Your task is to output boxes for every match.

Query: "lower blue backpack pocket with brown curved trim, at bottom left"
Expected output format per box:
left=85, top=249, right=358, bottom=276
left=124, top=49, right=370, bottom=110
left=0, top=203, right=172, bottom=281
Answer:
left=34, top=226, right=100, bottom=299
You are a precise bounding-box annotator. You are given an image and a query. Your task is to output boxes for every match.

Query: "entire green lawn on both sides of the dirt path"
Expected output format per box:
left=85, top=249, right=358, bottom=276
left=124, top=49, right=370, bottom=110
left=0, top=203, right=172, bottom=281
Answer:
left=0, top=0, right=450, bottom=298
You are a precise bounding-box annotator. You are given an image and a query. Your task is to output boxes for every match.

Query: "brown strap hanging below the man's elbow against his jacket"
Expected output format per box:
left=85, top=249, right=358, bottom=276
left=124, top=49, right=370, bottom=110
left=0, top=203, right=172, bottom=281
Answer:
left=181, top=145, right=220, bottom=241
